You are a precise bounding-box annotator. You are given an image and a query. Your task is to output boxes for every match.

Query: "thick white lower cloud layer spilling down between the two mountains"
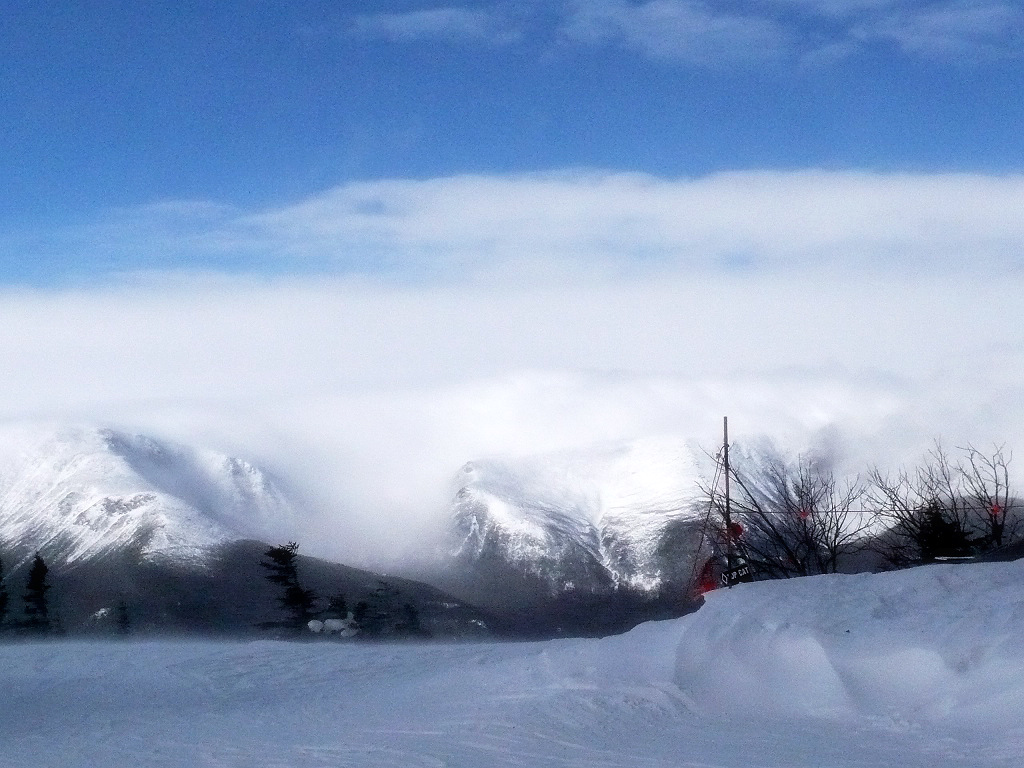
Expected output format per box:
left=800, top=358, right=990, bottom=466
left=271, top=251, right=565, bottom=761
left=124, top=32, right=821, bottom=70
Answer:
left=0, top=272, right=1024, bottom=562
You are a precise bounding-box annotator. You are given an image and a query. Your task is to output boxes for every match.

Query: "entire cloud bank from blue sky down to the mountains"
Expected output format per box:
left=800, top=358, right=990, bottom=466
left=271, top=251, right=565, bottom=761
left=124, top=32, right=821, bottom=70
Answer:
left=0, top=166, right=1024, bottom=564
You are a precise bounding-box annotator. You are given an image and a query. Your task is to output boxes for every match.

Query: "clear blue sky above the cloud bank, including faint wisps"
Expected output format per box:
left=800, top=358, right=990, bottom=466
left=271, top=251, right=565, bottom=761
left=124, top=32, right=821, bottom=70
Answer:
left=6, top=0, right=1024, bottom=284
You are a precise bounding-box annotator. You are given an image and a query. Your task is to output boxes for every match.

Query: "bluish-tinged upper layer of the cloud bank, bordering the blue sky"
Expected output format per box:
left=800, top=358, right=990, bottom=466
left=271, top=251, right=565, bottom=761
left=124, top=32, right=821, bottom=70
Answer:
left=14, top=170, right=1024, bottom=283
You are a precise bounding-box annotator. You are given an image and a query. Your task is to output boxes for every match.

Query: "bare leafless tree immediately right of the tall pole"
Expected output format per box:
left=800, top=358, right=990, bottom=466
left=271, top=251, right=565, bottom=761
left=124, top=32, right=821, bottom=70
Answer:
left=705, top=446, right=869, bottom=579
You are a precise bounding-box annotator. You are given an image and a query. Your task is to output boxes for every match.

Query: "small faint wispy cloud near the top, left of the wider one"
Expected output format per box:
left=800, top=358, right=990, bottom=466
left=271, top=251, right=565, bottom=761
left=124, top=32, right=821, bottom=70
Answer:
left=351, top=6, right=519, bottom=44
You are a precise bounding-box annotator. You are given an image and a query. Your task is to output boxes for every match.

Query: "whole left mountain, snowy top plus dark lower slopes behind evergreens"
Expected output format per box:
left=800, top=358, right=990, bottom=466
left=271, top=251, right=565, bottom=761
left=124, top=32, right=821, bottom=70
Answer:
left=0, top=426, right=492, bottom=636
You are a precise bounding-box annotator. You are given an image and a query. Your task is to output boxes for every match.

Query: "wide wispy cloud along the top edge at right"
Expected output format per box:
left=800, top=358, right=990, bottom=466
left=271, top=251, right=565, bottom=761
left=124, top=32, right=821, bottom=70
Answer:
left=562, top=0, right=1024, bottom=66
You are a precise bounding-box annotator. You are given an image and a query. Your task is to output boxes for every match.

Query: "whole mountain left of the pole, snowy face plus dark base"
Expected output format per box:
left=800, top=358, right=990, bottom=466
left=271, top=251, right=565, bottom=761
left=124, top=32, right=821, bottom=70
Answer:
left=445, top=440, right=702, bottom=632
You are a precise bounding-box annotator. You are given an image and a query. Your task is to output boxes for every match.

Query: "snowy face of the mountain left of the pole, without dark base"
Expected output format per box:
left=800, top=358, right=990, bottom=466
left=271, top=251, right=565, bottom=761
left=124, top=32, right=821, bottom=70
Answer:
left=451, top=438, right=700, bottom=614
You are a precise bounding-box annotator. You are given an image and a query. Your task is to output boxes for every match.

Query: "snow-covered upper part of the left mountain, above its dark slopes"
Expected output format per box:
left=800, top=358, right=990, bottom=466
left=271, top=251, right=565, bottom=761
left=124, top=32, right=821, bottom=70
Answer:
left=0, top=425, right=294, bottom=563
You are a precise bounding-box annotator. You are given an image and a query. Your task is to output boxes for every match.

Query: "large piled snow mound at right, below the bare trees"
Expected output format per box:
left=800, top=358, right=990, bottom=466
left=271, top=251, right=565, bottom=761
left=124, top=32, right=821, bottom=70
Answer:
left=675, top=562, right=1024, bottom=727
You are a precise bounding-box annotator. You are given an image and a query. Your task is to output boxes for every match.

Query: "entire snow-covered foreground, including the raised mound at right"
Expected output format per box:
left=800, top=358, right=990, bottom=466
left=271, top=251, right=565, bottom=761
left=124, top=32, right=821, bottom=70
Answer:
left=0, top=563, right=1024, bottom=768
